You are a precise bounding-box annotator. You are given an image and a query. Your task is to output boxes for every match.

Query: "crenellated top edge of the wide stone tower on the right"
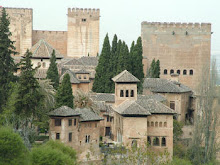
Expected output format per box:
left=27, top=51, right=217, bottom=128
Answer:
left=141, top=21, right=211, bottom=29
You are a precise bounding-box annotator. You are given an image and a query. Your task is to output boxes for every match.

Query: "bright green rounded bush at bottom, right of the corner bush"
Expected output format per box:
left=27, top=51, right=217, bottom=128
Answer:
left=31, top=141, right=76, bottom=165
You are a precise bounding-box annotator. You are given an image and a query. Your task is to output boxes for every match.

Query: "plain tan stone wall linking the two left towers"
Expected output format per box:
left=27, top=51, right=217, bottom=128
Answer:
left=32, top=30, right=67, bottom=56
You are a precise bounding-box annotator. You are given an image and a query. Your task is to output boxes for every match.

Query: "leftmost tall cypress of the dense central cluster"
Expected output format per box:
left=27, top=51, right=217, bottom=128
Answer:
left=92, top=34, right=112, bottom=93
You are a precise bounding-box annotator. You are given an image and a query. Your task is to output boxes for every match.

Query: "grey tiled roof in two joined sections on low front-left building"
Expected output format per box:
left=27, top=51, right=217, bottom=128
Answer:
left=48, top=106, right=103, bottom=121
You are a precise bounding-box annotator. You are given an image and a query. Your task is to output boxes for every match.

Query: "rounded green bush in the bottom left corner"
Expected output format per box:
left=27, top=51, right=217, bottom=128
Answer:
left=0, top=127, right=28, bottom=165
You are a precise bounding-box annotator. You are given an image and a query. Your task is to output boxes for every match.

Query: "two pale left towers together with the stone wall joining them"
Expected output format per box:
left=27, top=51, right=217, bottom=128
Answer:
left=1, top=8, right=100, bottom=57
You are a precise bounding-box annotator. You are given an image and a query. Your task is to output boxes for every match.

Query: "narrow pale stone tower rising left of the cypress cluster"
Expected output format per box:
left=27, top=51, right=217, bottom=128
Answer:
left=67, top=8, right=100, bottom=57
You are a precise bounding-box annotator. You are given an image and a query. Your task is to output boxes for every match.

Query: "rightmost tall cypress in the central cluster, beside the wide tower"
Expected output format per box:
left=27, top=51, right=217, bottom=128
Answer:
left=133, top=37, right=144, bottom=93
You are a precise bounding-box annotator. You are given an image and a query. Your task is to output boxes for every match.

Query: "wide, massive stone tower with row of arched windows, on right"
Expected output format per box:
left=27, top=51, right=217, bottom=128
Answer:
left=141, top=22, right=211, bottom=90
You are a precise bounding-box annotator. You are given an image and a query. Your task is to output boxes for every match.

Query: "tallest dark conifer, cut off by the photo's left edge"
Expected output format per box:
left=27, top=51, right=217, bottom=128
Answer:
left=0, top=8, right=16, bottom=112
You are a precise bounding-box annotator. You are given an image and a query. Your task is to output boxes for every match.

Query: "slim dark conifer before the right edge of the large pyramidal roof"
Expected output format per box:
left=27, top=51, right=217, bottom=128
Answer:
left=47, top=50, right=59, bottom=89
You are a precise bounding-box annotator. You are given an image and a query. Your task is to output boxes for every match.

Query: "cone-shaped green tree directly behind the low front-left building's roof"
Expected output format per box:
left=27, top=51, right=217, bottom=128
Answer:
left=55, top=74, right=74, bottom=108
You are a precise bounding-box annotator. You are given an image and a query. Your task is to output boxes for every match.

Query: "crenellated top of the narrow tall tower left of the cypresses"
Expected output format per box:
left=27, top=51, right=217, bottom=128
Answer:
left=68, top=8, right=100, bottom=16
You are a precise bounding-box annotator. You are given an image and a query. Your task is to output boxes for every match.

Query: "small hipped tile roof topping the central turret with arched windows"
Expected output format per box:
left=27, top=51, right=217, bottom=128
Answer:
left=112, top=70, right=140, bottom=83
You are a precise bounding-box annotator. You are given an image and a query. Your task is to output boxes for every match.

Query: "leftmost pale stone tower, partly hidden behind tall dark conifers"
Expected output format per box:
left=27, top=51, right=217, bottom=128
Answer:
left=0, top=8, right=33, bottom=55
